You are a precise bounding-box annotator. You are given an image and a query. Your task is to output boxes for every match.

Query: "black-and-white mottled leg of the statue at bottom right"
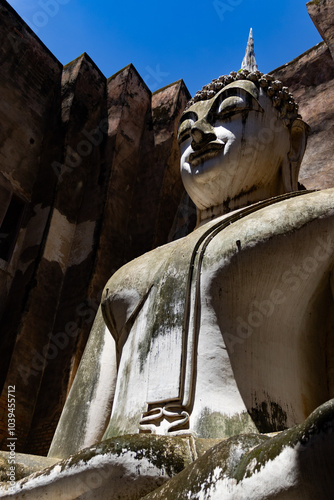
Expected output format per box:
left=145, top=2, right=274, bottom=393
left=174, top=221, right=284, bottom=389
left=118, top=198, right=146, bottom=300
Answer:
left=144, top=400, right=334, bottom=500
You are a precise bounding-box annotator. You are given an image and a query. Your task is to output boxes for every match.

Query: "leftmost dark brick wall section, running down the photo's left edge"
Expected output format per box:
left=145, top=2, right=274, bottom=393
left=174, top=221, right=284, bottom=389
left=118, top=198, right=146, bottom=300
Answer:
left=0, top=2, right=62, bottom=446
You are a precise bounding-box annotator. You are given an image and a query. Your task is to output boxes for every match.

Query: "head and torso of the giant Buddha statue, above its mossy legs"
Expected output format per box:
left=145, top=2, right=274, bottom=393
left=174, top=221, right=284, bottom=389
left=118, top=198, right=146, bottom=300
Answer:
left=1, top=70, right=334, bottom=499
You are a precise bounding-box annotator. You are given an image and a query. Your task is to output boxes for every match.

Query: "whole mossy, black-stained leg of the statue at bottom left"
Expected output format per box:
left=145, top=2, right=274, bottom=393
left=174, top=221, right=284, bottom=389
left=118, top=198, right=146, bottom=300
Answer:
left=0, top=435, right=198, bottom=500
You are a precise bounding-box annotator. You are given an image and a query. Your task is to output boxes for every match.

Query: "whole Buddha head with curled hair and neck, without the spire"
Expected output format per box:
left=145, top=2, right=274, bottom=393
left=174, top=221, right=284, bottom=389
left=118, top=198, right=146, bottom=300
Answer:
left=178, top=70, right=308, bottom=220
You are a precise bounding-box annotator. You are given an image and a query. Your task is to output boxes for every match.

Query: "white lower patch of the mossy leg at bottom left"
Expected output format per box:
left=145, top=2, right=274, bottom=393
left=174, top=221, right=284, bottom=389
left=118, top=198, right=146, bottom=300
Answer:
left=0, top=449, right=168, bottom=500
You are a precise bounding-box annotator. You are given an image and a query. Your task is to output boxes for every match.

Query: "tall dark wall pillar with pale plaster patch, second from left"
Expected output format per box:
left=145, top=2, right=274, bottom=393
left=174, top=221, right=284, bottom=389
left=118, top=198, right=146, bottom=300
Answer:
left=21, top=55, right=106, bottom=451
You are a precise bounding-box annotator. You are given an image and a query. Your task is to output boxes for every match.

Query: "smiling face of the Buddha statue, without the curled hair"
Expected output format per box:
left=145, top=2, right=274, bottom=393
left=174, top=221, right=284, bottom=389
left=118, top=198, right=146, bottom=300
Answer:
left=178, top=81, right=290, bottom=210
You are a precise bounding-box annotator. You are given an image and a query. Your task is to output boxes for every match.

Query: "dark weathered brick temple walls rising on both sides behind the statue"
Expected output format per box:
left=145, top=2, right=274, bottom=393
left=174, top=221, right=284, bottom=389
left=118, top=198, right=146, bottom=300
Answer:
left=0, top=0, right=334, bottom=453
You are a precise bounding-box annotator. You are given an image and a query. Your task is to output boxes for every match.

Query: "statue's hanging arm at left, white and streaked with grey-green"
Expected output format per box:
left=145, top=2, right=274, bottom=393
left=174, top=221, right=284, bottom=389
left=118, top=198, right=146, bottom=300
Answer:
left=49, top=308, right=117, bottom=458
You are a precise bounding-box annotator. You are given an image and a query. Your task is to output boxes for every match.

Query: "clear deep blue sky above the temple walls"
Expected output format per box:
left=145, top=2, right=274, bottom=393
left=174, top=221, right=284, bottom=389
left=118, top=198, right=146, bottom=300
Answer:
left=8, top=0, right=321, bottom=95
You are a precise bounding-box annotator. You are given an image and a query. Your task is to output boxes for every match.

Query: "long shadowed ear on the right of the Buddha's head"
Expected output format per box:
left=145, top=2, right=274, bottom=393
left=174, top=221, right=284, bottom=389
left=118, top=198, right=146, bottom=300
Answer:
left=283, top=118, right=310, bottom=191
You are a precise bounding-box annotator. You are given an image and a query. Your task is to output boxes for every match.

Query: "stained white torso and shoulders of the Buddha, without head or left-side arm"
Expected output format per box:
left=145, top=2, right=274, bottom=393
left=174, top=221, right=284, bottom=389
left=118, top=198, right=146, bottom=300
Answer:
left=96, top=189, right=334, bottom=438
